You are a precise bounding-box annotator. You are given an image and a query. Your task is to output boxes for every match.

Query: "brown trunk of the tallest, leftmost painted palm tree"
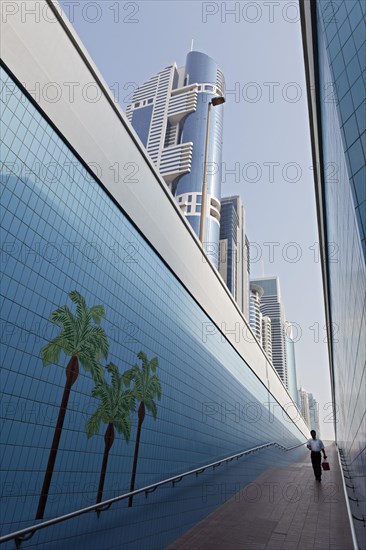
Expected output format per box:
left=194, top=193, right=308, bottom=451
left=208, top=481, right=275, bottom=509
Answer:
left=36, top=355, right=79, bottom=519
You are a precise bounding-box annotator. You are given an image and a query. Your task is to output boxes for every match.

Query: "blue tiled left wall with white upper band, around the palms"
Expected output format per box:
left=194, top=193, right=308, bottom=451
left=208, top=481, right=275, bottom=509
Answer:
left=0, top=6, right=307, bottom=550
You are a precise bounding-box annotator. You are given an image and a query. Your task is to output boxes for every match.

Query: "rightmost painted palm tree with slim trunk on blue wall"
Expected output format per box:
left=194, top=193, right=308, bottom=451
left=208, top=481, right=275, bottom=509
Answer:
left=124, top=351, right=161, bottom=506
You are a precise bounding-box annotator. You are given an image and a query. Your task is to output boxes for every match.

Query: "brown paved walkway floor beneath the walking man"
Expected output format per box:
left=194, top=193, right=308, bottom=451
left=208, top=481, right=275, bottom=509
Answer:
left=166, top=442, right=353, bottom=550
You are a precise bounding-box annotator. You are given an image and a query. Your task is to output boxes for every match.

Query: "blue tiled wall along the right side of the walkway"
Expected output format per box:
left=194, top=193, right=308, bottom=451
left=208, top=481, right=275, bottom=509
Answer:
left=300, top=0, right=366, bottom=547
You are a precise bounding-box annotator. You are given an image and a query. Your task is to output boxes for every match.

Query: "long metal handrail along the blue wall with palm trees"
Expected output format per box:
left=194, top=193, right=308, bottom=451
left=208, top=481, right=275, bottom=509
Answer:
left=0, top=441, right=305, bottom=547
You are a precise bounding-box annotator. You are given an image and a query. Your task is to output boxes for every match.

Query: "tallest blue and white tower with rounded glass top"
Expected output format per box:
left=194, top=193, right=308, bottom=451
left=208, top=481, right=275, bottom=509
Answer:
left=126, top=51, right=224, bottom=267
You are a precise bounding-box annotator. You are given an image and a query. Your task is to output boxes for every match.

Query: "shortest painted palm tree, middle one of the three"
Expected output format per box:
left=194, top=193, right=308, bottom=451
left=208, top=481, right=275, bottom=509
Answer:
left=85, top=363, right=135, bottom=504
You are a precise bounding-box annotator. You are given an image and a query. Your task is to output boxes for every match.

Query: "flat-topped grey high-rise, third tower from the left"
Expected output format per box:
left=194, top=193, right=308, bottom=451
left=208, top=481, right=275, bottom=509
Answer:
left=251, top=277, right=288, bottom=387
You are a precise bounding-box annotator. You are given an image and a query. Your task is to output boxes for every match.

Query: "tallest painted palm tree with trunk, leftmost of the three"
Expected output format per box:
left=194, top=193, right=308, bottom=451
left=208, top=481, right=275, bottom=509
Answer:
left=36, top=290, right=108, bottom=519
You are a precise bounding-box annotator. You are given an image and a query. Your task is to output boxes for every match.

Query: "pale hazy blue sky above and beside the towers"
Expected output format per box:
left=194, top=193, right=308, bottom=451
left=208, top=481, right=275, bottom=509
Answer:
left=60, top=0, right=333, bottom=439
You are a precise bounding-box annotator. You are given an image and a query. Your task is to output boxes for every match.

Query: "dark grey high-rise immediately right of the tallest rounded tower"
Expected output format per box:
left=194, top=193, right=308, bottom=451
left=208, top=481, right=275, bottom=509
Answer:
left=219, top=195, right=249, bottom=319
